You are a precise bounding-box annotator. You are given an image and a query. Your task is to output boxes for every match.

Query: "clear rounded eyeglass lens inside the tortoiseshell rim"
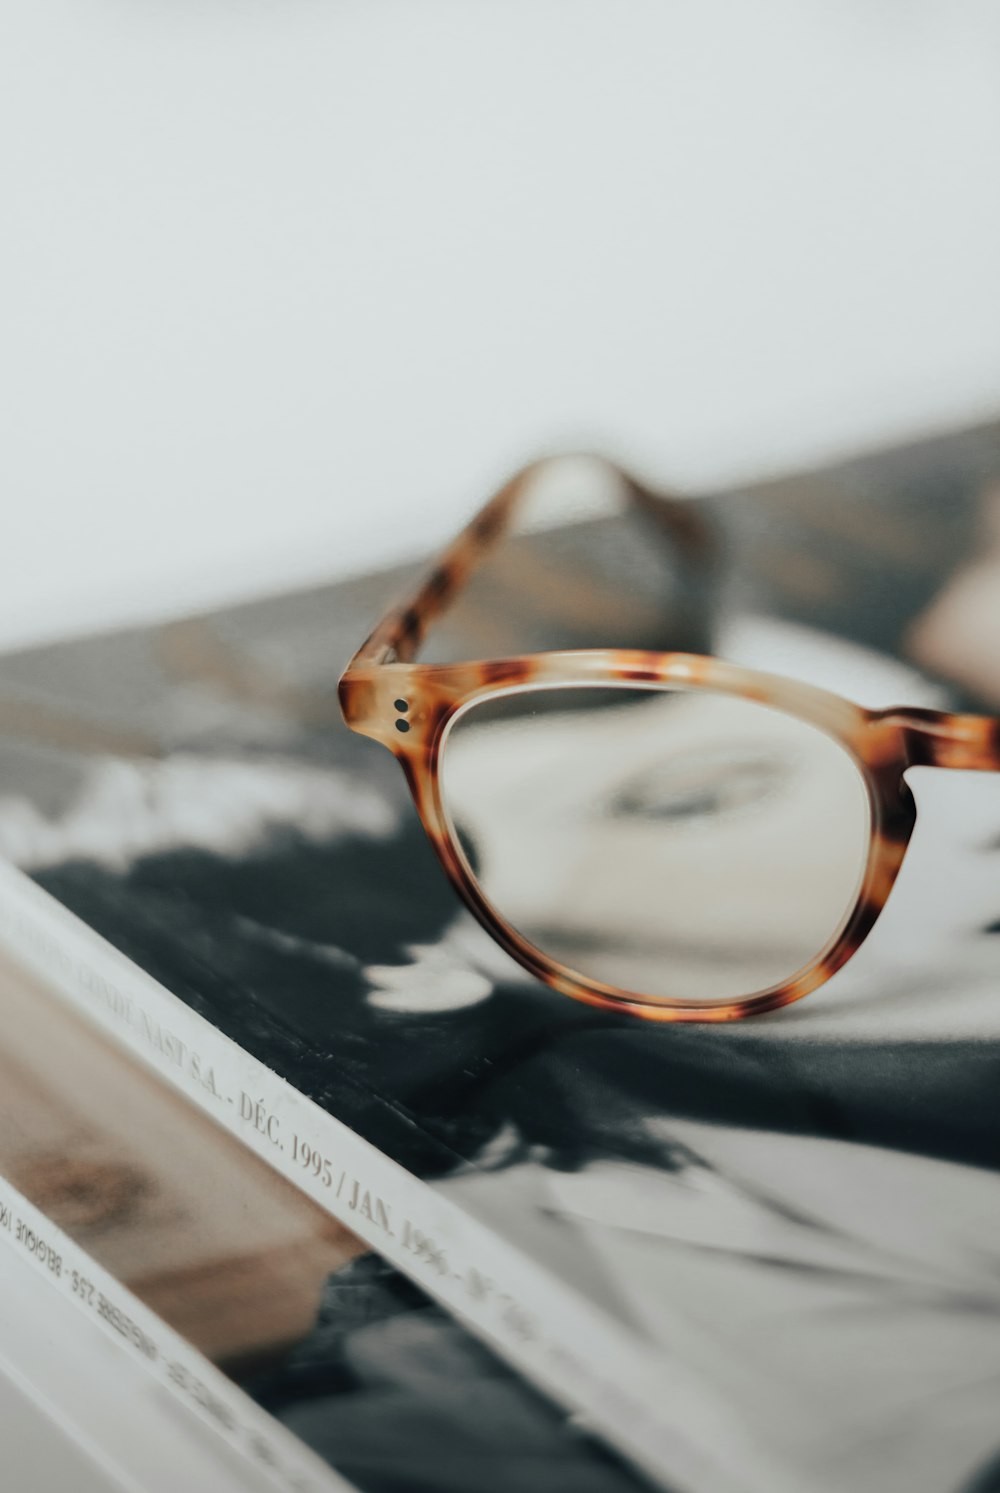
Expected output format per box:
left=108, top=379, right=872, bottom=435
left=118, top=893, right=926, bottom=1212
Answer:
left=440, top=685, right=870, bottom=1002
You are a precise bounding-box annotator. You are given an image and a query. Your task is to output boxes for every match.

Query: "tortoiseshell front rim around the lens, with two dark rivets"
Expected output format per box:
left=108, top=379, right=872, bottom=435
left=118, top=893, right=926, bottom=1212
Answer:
left=342, top=649, right=955, bottom=1021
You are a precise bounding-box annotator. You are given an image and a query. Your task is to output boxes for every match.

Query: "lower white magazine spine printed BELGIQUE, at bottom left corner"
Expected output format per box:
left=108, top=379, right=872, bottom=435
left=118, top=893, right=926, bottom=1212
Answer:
left=0, top=1178, right=354, bottom=1493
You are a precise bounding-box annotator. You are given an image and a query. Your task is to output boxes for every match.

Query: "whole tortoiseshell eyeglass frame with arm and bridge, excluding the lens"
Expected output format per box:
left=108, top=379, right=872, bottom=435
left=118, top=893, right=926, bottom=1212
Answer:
left=339, top=457, right=1000, bottom=1021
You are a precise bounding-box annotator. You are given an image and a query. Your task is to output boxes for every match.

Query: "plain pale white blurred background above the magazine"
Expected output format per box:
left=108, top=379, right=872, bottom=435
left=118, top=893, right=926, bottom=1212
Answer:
left=0, top=0, right=1000, bottom=645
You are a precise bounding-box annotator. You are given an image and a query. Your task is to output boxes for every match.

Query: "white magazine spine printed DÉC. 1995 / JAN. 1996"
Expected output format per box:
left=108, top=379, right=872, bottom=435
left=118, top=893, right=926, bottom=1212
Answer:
left=0, top=863, right=804, bottom=1493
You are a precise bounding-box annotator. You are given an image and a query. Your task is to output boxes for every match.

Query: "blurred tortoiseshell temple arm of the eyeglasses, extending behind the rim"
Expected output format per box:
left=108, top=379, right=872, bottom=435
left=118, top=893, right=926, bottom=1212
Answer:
left=349, top=457, right=718, bottom=667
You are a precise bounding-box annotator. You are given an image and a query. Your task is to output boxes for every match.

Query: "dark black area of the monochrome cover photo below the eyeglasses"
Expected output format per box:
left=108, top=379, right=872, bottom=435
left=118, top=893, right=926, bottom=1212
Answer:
left=37, top=800, right=1000, bottom=1176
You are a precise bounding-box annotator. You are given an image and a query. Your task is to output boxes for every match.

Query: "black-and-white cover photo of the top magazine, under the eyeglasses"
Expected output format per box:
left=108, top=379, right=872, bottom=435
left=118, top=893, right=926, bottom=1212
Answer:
left=0, top=418, right=1000, bottom=1493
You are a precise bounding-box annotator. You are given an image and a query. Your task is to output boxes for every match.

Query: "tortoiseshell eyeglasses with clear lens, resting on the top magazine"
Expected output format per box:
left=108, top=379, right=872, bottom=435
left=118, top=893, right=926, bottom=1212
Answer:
left=340, top=447, right=1000, bottom=1021
